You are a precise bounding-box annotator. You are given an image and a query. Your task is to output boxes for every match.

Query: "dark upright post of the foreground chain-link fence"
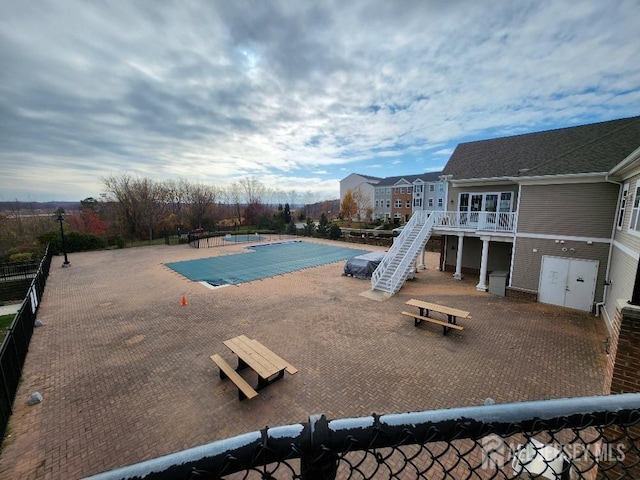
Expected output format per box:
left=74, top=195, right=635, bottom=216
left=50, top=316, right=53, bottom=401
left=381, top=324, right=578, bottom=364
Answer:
left=300, top=415, right=338, bottom=480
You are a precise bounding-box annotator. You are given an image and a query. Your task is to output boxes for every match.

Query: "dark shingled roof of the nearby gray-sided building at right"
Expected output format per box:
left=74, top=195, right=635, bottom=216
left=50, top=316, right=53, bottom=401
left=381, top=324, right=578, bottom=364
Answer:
left=442, top=116, right=640, bottom=180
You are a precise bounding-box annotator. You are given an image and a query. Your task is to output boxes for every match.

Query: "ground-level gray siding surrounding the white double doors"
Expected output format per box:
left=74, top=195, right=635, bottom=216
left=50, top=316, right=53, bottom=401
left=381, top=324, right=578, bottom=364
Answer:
left=511, top=237, right=609, bottom=302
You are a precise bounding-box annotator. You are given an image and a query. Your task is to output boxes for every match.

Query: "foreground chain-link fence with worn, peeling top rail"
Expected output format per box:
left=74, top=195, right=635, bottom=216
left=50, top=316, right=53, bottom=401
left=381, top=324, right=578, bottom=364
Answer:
left=85, top=394, right=640, bottom=480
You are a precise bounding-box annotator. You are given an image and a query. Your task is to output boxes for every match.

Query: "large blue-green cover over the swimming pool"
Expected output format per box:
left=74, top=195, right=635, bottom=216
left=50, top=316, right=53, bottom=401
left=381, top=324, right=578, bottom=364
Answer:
left=166, top=241, right=367, bottom=286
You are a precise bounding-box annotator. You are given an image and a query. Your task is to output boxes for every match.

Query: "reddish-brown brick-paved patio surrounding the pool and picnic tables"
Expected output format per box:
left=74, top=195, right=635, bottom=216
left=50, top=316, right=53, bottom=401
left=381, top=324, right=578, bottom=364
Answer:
left=0, top=240, right=606, bottom=479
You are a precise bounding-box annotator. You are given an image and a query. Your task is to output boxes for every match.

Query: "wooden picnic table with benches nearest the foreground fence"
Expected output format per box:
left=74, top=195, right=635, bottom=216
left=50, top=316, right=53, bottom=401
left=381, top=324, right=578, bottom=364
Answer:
left=210, top=335, right=298, bottom=400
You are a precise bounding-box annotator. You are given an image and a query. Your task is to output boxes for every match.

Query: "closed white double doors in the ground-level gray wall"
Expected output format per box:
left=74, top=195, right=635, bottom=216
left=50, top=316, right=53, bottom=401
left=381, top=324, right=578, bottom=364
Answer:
left=538, top=255, right=599, bottom=312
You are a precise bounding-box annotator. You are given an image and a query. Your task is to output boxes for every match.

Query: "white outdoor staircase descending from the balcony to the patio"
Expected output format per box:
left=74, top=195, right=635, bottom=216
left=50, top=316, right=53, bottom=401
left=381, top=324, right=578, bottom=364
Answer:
left=371, top=211, right=438, bottom=295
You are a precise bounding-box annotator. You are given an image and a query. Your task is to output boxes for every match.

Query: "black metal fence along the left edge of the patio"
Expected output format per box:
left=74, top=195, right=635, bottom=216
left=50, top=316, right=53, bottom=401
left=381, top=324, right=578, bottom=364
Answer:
left=0, top=246, right=51, bottom=439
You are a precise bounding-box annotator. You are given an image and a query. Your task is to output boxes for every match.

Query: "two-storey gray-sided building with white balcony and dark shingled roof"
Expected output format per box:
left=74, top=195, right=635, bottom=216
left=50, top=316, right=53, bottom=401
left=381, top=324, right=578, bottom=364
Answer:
left=436, top=117, right=640, bottom=311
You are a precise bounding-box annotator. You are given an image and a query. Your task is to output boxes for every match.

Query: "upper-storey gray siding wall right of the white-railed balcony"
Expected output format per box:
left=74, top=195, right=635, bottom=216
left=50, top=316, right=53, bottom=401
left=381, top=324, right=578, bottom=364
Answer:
left=518, top=182, right=619, bottom=238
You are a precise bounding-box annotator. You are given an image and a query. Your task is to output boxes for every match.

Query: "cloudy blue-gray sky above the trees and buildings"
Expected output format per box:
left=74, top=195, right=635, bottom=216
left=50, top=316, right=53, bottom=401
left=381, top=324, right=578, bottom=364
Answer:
left=0, top=0, right=640, bottom=201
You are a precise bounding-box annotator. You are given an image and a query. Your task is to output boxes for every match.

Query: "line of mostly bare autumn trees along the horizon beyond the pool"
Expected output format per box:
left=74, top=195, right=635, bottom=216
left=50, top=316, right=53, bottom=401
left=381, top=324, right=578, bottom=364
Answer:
left=0, top=173, right=339, bottom=261
